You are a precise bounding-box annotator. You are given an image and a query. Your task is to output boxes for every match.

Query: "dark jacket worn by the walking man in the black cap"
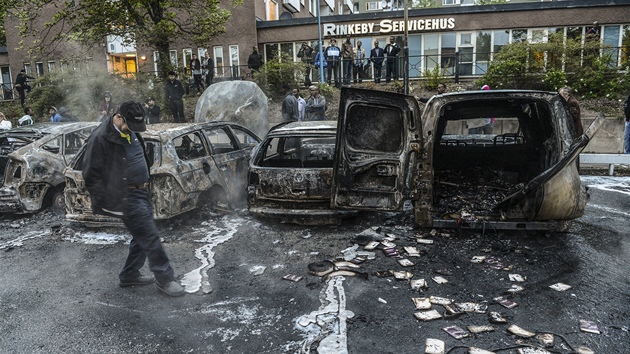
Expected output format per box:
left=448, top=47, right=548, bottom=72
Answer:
left=83, top=117, right=149, bottom=217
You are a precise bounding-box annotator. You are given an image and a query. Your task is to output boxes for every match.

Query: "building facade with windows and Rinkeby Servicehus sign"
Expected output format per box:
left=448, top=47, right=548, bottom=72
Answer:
left=0, top=0, right=630, bottom=100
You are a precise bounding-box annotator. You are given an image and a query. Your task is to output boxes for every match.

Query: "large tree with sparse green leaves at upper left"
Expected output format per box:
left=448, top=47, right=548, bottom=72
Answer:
left=8, top=0, right=243, bottom=76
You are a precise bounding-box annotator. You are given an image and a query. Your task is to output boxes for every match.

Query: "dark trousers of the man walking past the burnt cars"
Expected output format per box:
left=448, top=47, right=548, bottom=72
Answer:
left=118, top=189, right=175, bottom=284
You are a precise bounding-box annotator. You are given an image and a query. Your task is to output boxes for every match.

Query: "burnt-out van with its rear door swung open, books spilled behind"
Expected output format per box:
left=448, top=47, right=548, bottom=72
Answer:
left=331, top=88, right=604, bottom=231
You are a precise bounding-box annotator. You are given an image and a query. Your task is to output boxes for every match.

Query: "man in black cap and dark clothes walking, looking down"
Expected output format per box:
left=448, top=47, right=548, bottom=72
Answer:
left=83, top=101, right=185, bottom=296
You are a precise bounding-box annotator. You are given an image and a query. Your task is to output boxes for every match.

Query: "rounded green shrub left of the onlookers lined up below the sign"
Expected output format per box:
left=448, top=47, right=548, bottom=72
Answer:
left=254, top=53, right=304, bottom=98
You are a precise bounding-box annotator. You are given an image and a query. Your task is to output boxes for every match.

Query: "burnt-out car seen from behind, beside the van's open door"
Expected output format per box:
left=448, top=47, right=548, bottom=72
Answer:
left=247, top=121, right=356, bottom=224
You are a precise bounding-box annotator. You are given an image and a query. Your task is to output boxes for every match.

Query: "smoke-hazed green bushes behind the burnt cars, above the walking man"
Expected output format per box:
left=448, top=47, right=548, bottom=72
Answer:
left=20, top=68, right=166, bottom=122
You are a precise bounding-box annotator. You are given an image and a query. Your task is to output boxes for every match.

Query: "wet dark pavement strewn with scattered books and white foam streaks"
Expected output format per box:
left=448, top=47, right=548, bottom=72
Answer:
left=0, top=177, right=630, bottom=354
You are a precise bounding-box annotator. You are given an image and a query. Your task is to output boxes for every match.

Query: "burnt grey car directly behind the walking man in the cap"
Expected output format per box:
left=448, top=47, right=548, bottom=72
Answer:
left=65, top=122, right=260, bottom=226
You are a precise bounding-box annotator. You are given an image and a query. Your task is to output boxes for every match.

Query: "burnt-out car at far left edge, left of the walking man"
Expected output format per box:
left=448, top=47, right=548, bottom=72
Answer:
left=0, top=122, right=98, bottom=214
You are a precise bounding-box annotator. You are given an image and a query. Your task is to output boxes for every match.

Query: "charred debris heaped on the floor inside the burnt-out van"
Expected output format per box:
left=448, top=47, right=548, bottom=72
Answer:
left=433, top=167, right=524, bottom=220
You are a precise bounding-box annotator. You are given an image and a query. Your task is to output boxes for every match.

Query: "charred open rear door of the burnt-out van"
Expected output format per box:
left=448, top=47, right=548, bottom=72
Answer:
left=331, top=88, right=423, bottom=211
